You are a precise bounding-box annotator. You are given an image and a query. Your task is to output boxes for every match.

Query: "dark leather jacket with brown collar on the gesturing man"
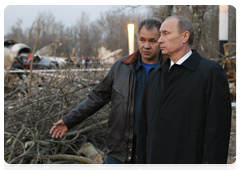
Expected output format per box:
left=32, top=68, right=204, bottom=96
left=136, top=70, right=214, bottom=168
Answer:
left=62, top=50, right=139, bottom=162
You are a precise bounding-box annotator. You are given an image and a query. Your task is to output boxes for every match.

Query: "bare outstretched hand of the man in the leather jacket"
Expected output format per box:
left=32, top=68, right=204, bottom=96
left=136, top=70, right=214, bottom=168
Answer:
left=50, top=119, right=68, bottom=138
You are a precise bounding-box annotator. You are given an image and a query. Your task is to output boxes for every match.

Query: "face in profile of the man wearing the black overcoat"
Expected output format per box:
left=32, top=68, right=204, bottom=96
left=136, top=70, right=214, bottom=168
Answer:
left=158, top=18, right=183, bottom=57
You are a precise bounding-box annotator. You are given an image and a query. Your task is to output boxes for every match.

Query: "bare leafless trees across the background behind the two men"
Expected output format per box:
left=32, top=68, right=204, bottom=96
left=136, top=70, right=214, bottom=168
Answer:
left=4, top=5, right=238, bottom=58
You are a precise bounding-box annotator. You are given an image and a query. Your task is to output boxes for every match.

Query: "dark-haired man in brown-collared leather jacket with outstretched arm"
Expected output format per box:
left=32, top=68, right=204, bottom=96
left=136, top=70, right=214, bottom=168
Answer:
left=50, top=19, right=163, bottom=170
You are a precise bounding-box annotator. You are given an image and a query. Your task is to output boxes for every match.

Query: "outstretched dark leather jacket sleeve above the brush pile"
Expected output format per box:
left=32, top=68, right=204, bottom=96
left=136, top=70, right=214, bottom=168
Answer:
left=62, top=63, right=116, bottom=130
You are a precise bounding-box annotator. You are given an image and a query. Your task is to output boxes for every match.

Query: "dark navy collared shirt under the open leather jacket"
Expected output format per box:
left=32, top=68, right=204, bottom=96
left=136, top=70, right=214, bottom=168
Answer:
left=134, top=54, right=161, bottom=135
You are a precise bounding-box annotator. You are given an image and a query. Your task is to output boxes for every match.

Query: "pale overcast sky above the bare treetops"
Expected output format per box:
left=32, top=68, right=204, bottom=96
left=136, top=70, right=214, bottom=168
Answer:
left=4, top=5, right=149, bottom=34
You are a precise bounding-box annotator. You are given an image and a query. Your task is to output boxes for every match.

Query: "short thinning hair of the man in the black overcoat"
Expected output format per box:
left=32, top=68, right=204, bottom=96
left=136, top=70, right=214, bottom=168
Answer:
left=166, top=15, right=194, bottom=47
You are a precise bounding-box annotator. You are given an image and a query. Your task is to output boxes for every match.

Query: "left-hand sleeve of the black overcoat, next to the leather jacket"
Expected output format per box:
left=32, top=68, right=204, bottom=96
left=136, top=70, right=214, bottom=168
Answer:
left=135, top=87, right=148, bottom=169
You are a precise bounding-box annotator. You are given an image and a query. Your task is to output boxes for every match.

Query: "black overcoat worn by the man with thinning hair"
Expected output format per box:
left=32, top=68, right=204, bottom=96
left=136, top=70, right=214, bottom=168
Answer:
left=136, top=50, right=231, bottom=170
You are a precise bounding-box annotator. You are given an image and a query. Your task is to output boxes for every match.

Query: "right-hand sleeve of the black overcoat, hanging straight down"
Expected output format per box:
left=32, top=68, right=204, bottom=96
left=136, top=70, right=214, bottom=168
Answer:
left=202, top=64, right=231, bottom=170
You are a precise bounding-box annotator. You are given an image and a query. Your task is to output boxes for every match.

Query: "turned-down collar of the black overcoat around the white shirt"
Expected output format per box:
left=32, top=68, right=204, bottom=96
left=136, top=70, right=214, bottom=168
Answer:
left=160, top=49, right=202, bottom=71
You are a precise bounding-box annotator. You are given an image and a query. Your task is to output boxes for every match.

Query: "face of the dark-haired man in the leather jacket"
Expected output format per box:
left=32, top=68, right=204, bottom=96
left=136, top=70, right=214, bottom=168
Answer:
left=138, top=25, right=160, bottom=64
